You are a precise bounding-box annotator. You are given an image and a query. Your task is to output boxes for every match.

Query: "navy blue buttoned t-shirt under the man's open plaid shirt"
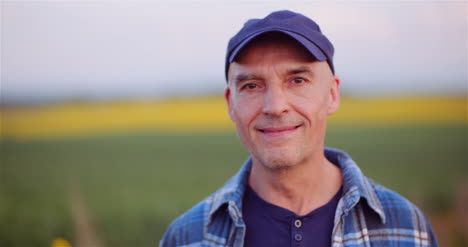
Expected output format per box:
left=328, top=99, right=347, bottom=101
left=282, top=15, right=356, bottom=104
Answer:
left=242, top=186, right=342, bottom=247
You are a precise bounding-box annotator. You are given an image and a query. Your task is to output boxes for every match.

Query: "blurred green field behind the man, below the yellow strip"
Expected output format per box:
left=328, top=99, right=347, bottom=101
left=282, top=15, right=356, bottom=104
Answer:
left=0, top=125, right=468, bottom=247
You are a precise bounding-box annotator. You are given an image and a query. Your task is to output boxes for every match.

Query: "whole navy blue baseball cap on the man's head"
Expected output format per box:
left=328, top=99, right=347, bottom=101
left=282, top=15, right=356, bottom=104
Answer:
left=225, top=10, right=335, bottom=80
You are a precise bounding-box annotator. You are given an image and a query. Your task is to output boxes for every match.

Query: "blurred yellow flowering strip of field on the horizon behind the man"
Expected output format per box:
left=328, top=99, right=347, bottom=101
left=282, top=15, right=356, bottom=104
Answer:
left=0, top=97, right=468, bottom=139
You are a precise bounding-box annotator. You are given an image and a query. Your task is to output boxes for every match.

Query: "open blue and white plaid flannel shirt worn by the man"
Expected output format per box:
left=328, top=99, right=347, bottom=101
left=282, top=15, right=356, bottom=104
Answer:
left=160, top=148, right=437, bottom=247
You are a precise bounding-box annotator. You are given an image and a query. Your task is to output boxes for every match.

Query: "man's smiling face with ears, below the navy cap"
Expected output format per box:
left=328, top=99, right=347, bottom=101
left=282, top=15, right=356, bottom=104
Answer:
left=225, top=37, right=339, bottom=169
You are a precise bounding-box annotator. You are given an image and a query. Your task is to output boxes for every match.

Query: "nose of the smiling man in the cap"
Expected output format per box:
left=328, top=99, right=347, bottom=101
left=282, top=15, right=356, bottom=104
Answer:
left=262, top=85, right=289, bottom=116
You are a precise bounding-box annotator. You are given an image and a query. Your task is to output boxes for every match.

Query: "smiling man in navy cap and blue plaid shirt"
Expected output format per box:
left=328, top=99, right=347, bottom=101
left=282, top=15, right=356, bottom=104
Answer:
left=160, top=11, right=437, bottom=247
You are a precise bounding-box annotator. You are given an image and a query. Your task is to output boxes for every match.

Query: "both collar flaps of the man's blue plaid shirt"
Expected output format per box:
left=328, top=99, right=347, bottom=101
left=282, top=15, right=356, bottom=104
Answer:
left=208, top=148, right=385, bottom=225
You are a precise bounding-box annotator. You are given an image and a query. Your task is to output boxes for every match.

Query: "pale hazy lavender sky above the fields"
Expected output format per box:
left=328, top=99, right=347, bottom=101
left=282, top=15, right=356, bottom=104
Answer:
left=0, top=0, right=468, bottom=102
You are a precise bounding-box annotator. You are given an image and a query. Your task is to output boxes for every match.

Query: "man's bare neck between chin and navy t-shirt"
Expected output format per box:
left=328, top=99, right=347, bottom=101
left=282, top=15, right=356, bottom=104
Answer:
left=249, top=155, right=342, bottom=215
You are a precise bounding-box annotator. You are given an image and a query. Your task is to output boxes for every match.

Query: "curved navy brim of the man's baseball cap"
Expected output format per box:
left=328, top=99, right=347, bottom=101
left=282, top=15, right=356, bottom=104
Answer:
left=228, top=28, right=327, bottom=64
